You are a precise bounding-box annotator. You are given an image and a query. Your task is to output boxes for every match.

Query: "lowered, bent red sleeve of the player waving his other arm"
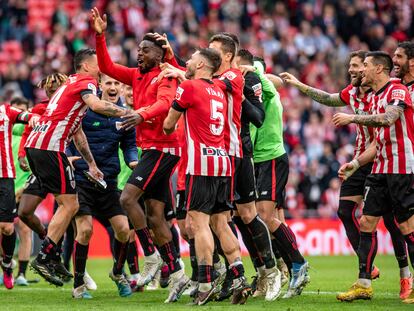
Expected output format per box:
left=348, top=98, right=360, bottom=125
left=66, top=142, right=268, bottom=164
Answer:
left=140, top=78, right=178, bottom=120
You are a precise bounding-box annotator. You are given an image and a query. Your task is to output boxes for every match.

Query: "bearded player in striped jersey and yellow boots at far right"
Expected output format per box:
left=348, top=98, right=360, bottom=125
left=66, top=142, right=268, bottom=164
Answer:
left=332, top=51, right=414, bottom=303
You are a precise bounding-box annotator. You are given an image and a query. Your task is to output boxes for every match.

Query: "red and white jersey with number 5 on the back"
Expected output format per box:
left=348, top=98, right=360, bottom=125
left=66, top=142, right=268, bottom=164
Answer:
left=172, top=79, right=231, bottom=176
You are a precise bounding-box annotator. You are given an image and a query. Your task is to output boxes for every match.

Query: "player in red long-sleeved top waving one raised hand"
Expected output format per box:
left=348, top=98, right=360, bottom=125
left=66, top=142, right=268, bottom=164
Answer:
left=91, top=8, right=190, bottom=303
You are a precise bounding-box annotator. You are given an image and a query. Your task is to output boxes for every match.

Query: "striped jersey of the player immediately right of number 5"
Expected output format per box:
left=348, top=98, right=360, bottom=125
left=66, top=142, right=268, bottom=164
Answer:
left=215, top=68, right=244, bottom=158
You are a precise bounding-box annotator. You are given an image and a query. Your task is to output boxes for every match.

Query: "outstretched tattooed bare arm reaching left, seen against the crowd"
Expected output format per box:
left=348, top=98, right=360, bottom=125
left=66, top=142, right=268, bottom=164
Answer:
left=280, top=72, right=346, bottom=107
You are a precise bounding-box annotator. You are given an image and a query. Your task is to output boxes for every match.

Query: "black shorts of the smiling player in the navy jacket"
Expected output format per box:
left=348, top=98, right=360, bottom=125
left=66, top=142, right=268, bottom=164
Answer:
left=76, top=182, right=126, bottom=224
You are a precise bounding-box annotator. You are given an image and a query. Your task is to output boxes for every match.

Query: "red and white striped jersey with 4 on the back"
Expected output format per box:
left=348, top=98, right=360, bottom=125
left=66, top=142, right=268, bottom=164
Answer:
left=25, top=74, right=97, bottom=152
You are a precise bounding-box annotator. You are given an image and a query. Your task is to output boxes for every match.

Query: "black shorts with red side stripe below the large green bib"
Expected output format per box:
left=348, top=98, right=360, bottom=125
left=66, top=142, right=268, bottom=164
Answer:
left=254, top=153, right=289, bottom=208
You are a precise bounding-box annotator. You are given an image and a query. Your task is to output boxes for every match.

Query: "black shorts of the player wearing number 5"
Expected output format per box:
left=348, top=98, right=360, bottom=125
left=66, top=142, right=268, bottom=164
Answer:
left=185, top=175, right=230, bottom=215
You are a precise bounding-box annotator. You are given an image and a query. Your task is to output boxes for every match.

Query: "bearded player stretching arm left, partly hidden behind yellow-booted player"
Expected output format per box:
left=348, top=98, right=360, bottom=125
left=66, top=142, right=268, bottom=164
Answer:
left=280, top=51, right=412, bottom=299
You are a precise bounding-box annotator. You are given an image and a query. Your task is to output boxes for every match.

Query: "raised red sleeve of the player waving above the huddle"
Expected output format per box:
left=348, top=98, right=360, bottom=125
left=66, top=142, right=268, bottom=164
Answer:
left=96, top=34, right=137, bottom=85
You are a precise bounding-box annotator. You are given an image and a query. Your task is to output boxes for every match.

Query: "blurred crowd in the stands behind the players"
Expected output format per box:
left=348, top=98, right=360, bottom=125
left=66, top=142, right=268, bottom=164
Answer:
left=0, top=0, right=414, bottom=218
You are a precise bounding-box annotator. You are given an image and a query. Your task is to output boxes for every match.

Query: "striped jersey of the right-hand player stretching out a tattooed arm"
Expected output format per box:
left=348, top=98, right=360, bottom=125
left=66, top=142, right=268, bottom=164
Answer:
left=339, top=84, right=374, bottom=158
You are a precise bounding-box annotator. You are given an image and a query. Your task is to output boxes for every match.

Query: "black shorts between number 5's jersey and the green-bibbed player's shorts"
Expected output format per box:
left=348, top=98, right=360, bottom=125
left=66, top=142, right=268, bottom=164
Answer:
left=230, top=157, right=257, bottom=204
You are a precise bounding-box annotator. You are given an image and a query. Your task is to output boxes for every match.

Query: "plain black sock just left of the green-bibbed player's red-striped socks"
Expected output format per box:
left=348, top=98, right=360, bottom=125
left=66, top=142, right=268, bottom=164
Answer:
left=247, top=215, right=275, bottom=269
